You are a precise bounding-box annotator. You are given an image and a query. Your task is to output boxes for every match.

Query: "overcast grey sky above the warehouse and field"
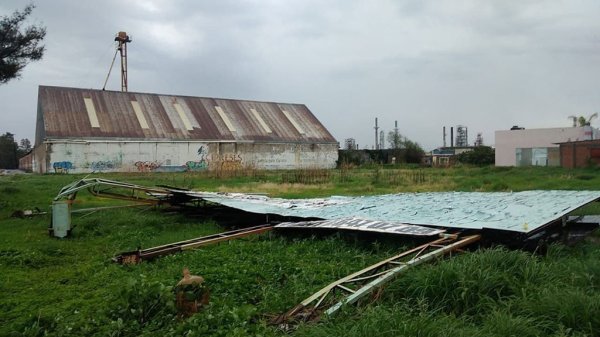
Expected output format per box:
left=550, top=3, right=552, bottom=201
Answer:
left=0, top=0, right=600, bottom=150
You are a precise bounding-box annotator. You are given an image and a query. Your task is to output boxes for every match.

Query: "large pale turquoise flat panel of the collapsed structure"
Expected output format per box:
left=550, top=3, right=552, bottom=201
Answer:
left=186, top=190, right=600, bottom=233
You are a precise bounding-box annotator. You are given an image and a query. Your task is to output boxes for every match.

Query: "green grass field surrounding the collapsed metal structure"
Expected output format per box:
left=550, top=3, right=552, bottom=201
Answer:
left=0, top=167, right=600, bottom=336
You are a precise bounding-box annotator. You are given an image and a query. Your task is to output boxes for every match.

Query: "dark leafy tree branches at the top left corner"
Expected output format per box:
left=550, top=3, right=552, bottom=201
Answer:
left=0, top=5, right=46, bottom=84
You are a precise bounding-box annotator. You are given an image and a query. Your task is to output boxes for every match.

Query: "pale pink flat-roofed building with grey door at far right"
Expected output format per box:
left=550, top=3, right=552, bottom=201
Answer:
left=495, top=126, right=598, bottom=166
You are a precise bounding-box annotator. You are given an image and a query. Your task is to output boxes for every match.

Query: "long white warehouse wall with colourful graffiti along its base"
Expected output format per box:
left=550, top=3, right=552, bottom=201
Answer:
left=34, top=141, right=338, bottom=173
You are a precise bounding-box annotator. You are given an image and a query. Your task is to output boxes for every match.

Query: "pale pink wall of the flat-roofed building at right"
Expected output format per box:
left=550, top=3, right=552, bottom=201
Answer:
left=495, top=126, right=597, bottom=166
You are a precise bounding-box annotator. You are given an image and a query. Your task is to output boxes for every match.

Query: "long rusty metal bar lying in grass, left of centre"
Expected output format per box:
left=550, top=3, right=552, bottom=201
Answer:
left=113, top=225, right=273, bottom=264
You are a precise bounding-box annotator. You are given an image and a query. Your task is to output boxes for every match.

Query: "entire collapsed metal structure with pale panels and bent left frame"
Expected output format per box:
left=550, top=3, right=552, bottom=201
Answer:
left=53, top=178, right=600, bottom=236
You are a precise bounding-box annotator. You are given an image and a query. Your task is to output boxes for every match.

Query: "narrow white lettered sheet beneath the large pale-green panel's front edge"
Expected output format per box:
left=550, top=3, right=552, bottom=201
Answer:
left=275, top=218, right=444, bottom=236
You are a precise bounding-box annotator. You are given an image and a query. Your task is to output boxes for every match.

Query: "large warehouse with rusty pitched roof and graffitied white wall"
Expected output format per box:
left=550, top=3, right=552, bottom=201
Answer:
left=31, top=86, right=338, bottom=173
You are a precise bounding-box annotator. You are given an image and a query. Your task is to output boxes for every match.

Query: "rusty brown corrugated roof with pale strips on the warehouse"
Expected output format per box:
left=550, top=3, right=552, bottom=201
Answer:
left=36, top=86, right=336, bottom=143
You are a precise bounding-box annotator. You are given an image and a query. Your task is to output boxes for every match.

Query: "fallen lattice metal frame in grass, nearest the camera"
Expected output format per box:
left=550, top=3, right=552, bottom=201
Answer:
left=271, top=234, right=481, bottom=324
